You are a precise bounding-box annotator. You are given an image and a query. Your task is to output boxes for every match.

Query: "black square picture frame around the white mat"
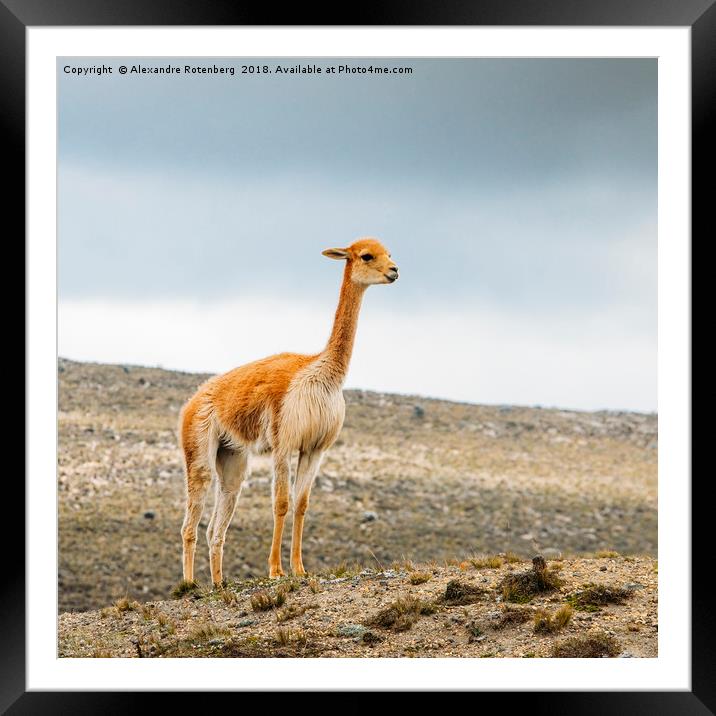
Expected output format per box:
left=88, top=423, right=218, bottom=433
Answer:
left=7, top=0, right=704, bottom=714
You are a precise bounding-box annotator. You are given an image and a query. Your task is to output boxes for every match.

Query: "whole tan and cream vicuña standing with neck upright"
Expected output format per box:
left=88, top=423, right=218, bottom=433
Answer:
left=179, top=238, right=398, bottom=584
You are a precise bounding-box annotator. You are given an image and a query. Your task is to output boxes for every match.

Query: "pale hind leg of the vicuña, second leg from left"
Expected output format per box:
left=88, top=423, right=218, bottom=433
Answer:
left=207, top=448, right=248, bottom=586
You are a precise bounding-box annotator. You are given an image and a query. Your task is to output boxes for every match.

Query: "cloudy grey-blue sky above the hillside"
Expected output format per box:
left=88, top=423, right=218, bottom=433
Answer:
left=58, top=58, right=657, bottom=412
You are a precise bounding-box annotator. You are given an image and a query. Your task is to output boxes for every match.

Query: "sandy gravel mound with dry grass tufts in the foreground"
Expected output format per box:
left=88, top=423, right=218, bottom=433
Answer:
left=59, top=553, right=658, bottom=658
